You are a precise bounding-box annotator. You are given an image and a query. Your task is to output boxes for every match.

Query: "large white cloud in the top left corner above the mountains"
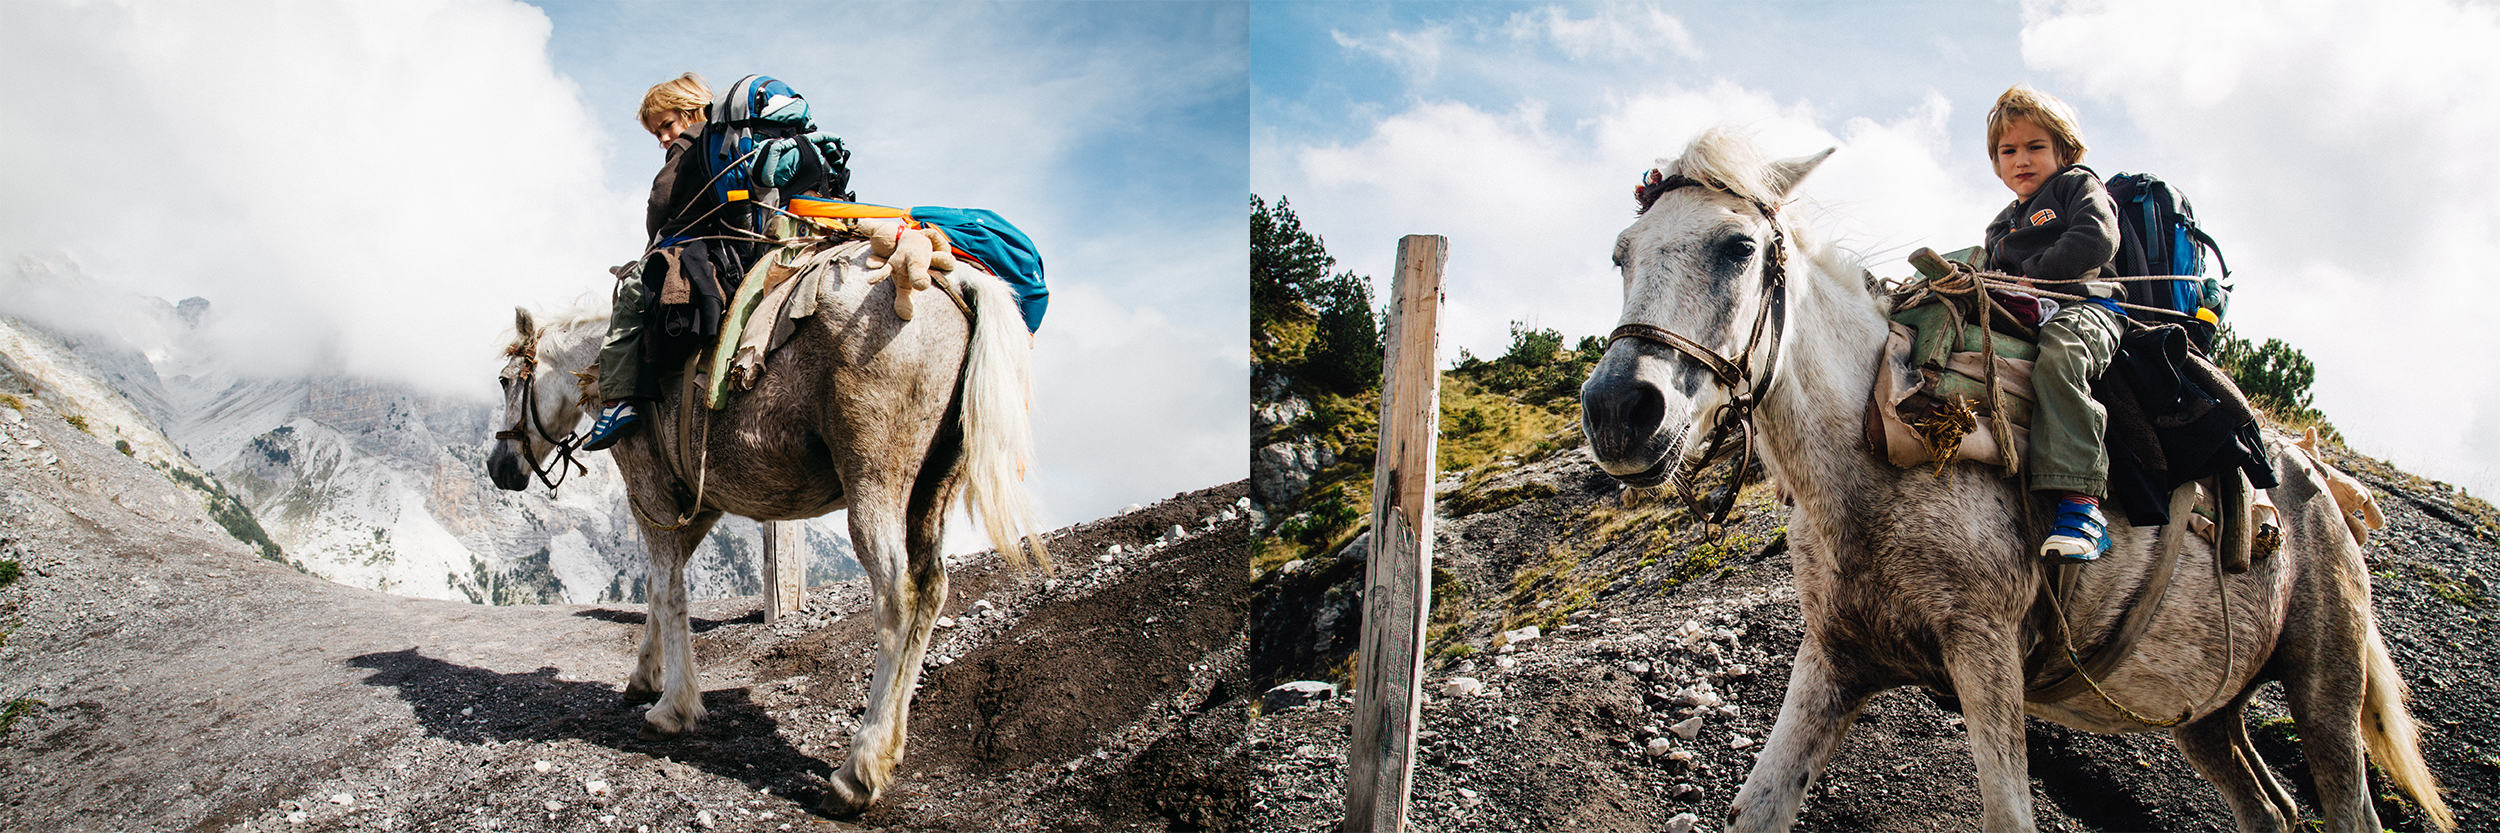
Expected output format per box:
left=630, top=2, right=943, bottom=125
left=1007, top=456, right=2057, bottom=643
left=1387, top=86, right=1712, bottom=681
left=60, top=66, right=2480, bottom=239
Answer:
left=0, top=0, right=640, bottom=390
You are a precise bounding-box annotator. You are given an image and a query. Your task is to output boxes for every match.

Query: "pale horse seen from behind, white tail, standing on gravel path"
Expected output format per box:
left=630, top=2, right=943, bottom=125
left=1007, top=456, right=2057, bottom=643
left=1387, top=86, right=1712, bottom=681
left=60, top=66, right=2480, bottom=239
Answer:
left=488, top=243, right=1048, bottom=815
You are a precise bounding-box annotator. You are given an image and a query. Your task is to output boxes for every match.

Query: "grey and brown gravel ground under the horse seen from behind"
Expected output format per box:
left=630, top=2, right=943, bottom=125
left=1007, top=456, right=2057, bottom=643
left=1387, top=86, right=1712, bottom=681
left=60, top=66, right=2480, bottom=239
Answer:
left=0, top=385, right=1258, bottom=833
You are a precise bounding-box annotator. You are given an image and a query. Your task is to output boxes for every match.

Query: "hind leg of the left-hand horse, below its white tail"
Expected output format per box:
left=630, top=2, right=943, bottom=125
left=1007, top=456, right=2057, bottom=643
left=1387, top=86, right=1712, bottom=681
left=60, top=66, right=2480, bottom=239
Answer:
left=823, top=482, right=948, bottom=815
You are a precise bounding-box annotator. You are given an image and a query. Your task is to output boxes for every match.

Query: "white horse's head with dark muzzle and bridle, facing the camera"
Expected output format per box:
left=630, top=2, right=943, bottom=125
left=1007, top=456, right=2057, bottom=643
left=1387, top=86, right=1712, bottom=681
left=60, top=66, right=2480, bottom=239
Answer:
left=1580, top=130, right=1830, bottom=485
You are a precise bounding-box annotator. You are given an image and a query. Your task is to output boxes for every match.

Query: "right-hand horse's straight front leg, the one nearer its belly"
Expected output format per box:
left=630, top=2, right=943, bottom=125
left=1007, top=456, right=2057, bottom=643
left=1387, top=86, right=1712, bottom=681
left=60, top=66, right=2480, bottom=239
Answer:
left=1945, top=623, right=2033, bottom=830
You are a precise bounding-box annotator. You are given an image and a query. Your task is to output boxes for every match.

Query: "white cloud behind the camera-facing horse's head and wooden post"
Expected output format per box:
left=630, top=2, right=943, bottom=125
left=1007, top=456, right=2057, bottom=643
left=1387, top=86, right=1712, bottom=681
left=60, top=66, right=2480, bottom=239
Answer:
left=1263, top=83, right=1995, bottom=360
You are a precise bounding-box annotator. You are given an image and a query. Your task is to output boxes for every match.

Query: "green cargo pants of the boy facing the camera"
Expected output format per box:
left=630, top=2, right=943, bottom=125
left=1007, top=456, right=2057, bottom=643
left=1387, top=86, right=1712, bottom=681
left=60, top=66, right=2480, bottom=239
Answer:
left=2025, top=303, right=2120, bottom=498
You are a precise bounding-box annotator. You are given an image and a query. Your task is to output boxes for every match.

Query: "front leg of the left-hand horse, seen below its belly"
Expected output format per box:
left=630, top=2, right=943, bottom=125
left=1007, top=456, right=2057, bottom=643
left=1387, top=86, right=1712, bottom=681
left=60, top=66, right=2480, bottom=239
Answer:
left=625, top=510, right=720, bottom=740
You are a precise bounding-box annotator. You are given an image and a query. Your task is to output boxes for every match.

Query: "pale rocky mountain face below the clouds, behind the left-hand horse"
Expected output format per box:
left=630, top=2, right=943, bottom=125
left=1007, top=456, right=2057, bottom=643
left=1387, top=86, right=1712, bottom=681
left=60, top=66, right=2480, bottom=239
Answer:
left=0, top=285, right=858, bottom=605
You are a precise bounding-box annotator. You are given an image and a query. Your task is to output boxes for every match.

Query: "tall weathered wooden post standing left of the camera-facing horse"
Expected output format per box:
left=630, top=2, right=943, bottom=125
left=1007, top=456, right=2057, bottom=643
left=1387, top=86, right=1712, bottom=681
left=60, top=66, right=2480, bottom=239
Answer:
left=1345, top=235, right=1450, bottom=833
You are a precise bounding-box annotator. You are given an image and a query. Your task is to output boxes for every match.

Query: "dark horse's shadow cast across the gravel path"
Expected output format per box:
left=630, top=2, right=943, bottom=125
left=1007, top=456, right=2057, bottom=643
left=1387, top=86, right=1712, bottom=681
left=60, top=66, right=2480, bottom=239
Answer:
left=348, top=648, right=833, bottom=808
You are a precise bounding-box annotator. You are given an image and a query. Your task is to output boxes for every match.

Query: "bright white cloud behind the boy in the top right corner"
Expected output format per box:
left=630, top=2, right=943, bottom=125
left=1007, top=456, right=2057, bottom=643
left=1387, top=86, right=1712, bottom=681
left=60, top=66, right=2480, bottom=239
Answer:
left=2023, top=0, right=2500, bottom=495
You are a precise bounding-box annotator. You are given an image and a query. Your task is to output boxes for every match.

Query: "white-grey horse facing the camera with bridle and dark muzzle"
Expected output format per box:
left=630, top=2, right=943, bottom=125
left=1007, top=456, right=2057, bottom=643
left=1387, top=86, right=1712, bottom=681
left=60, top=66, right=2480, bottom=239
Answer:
left=1580, top=130, right=2453, bottom=830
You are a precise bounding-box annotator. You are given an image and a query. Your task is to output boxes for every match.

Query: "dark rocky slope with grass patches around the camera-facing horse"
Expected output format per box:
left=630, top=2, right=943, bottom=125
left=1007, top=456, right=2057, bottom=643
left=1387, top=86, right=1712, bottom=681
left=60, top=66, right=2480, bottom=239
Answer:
left=1245, top=437, right=2500, bottom=833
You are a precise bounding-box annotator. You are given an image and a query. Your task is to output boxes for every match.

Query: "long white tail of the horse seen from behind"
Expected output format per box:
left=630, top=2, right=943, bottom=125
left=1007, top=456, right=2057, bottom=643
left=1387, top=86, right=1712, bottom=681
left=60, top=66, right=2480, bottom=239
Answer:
left=955, top=268, right=1050, bottom=573
